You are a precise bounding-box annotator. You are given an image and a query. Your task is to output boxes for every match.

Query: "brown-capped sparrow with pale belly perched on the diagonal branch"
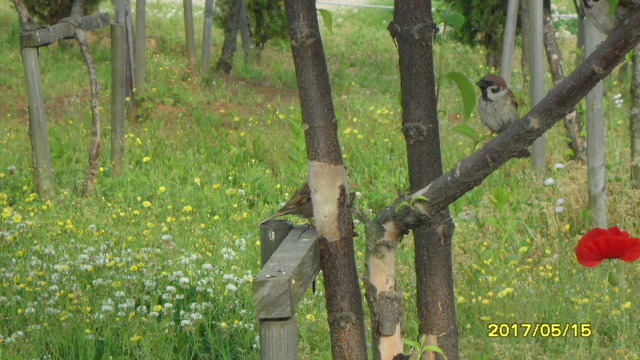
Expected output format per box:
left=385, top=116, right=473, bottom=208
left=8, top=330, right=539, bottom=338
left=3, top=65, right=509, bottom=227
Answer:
left=476, top=74, right=531, bottom=158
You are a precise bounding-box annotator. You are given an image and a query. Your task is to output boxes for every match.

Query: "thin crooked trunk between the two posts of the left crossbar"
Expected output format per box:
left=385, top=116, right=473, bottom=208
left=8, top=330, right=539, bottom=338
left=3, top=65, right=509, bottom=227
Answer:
left=71, top=0, right=100, bottom=196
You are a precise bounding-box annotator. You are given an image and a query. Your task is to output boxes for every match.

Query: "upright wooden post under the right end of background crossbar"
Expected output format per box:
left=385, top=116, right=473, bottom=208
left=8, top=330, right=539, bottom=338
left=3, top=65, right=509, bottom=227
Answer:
left=111, top=23, right=126, bottom=177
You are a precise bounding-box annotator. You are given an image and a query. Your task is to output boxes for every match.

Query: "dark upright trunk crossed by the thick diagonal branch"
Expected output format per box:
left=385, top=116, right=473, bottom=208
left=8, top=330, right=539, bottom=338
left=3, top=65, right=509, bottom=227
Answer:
left=391, top=0, right=458, bottom=359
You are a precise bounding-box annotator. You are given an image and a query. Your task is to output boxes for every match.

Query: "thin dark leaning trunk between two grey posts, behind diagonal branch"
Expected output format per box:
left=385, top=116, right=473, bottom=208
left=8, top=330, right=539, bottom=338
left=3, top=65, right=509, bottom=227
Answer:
left=543, top=0, right=587, bottom=162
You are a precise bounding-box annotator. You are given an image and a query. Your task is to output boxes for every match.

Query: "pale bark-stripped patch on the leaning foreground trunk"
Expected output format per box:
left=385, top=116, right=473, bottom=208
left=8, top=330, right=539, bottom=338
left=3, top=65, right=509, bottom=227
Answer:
left=307, top=161, right=349, bottom=242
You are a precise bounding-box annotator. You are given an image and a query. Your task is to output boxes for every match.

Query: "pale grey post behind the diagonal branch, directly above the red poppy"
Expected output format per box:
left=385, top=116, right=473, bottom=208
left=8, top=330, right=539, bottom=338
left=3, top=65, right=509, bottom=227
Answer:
left=584, top=18, right=607, bottom=228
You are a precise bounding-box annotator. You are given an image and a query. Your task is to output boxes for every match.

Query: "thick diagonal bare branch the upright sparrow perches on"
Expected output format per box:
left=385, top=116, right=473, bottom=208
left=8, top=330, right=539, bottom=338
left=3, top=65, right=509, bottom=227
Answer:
left=404, top=7, right=640, bottom=219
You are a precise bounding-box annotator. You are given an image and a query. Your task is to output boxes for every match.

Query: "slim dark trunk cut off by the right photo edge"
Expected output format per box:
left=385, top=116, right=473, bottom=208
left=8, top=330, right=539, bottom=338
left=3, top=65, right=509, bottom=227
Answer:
left=630, top=44, right=640, bottom=189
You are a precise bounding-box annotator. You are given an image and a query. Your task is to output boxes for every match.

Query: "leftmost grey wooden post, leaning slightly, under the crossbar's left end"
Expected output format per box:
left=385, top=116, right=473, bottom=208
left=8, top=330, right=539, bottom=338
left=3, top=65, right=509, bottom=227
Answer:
left=21, top=47, right=54, bottom=197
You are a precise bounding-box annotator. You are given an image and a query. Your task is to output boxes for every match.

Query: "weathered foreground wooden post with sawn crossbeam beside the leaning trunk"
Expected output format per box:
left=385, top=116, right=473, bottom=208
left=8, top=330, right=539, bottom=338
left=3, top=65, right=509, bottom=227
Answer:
left=253, top=225, right=320, bottom=360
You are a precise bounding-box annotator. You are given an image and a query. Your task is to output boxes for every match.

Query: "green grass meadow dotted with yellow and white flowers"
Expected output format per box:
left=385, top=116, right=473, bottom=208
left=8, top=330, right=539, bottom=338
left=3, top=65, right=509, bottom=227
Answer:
left=0, top=2, right=640, bottom=359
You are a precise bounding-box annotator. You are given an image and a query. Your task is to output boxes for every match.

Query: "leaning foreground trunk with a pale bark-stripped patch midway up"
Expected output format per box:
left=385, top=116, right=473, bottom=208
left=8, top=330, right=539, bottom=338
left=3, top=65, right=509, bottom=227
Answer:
left=285, top=0, right=367, bottom=360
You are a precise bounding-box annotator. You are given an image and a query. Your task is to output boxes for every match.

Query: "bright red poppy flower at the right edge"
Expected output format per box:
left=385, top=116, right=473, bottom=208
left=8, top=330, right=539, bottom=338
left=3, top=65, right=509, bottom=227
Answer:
left=576, top=227, right=640, bottom=267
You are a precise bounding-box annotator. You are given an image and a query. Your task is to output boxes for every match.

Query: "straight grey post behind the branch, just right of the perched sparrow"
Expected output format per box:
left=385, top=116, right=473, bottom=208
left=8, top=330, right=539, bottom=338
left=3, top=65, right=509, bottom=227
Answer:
left=528, top=0, right=547, bottom=177
